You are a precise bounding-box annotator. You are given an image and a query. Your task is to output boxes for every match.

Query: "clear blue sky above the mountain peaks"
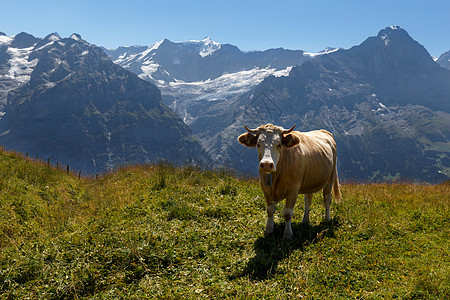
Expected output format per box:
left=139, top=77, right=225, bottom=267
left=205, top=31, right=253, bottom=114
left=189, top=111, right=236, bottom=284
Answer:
left=0, top=0, right=450, bottom=56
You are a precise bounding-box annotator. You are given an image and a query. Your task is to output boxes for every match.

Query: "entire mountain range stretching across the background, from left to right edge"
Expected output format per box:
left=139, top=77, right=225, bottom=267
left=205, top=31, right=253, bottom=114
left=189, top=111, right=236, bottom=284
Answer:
left=0, top=26, right=450, bottom=182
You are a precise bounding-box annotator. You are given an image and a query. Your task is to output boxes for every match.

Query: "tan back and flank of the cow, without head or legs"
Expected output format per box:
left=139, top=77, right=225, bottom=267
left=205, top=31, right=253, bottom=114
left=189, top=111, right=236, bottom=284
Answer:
left=282, top=130, right=336, bottom=194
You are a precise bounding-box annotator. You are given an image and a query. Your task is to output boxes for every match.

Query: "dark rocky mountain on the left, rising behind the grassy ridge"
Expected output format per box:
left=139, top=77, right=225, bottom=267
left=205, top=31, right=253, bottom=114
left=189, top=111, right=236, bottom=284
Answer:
left=0, top=34, right=207, bottom=173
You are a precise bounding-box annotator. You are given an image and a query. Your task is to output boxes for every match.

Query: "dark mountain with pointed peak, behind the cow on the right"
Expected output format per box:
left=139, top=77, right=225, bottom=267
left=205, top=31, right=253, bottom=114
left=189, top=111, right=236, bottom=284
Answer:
left=191, top=26, right=450, bottom=181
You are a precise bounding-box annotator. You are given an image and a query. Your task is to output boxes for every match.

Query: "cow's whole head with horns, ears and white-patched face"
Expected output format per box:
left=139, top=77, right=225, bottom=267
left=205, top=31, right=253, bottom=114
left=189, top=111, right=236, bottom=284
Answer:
left=238, top=124, right=300, bottom=173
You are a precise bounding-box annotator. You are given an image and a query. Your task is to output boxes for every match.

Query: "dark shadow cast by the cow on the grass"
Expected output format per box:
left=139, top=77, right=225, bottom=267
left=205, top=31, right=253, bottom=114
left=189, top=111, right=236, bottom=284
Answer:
left=230, top=218, right=339, bottom=280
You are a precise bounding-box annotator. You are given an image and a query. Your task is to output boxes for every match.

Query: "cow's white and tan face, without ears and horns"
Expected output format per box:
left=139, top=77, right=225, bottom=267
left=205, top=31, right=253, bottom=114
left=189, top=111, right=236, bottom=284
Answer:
left=256, top=131, right=282, bottom=173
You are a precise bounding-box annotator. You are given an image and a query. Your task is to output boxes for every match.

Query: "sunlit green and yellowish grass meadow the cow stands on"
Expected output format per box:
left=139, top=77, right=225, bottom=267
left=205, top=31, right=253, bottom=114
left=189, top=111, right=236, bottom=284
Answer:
left=0, top=153, right=450, bottom=299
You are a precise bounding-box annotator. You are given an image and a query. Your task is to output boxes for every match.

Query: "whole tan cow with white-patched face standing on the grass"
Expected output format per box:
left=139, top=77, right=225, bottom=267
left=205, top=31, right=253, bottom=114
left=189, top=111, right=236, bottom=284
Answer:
left=238, top=124, right=341, bottom=239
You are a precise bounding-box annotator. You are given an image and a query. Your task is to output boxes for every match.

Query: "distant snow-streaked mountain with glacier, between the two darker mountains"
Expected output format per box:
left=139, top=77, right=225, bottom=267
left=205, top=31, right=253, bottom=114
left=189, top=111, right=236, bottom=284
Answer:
left=105, top=38, right=310, bottom=124
